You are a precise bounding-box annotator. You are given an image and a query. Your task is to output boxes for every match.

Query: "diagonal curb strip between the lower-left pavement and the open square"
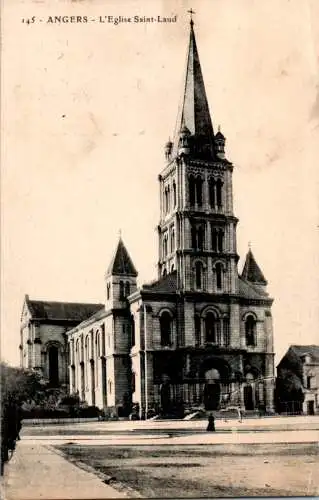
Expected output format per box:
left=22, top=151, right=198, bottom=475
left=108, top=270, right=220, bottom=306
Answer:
left=48, top=442, right=144, bottom=498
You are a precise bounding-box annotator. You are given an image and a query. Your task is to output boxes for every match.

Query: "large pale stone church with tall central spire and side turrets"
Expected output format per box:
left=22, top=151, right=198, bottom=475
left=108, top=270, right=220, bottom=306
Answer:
left=20, top=19, right=274, bottom=418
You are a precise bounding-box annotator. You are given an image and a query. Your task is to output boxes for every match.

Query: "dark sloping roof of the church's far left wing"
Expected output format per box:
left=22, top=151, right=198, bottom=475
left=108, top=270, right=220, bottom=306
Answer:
left=26, top=299, right=104, bottom=323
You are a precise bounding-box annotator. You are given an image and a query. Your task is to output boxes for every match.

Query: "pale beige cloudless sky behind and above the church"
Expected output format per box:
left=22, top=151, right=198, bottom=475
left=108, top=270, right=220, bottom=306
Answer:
left=1, top=0, right=319, bottom=364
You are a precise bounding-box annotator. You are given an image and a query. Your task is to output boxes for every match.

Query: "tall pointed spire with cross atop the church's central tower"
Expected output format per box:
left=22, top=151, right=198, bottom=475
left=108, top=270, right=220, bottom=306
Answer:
left=173, top=15, right=216, bottom=159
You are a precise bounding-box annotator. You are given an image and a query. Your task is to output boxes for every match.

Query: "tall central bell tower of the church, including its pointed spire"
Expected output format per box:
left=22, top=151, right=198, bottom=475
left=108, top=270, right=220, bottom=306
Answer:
left=158, top=17, right=239, bottom=294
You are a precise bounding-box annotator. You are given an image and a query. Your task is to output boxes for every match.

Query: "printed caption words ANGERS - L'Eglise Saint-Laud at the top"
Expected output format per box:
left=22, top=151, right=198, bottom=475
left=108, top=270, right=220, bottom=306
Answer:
left=47, top=15, right=177, bottom=25
